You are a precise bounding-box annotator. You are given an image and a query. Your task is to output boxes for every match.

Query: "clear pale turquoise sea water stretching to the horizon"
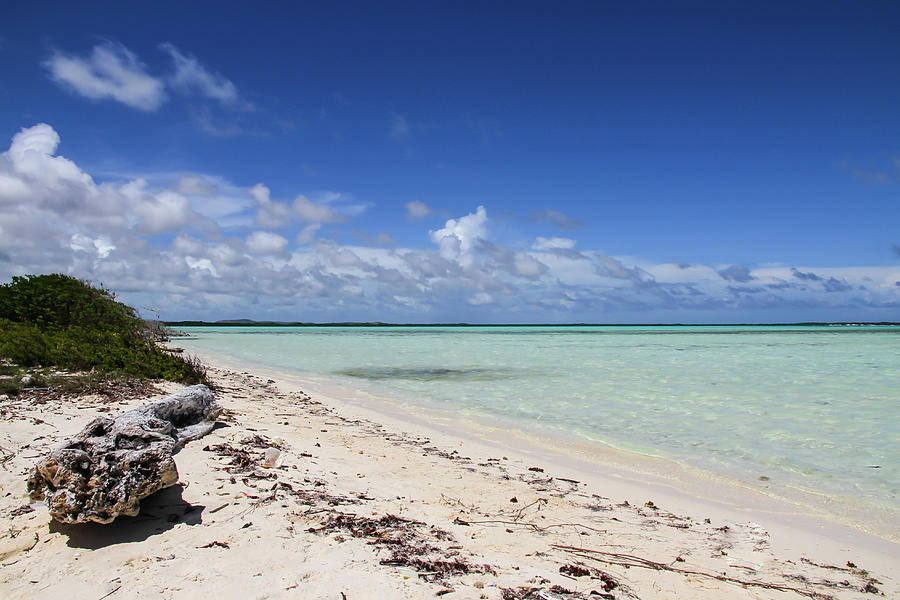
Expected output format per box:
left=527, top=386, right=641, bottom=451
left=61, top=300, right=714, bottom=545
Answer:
left=178, top=326, right=900, bottom=514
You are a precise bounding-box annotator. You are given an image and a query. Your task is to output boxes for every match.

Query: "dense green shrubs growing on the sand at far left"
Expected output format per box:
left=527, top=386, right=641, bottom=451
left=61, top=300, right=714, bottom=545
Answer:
left=0, top=273, right=206, bottom=393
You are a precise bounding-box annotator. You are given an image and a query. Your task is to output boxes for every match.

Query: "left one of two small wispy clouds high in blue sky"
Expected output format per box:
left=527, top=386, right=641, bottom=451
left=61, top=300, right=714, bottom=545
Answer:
left=44, top=42, right=166, bottom=112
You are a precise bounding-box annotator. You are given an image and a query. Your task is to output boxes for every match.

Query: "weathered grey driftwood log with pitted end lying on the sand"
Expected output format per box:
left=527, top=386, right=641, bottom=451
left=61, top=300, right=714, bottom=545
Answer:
left=28, top=385, right=222, bottom=523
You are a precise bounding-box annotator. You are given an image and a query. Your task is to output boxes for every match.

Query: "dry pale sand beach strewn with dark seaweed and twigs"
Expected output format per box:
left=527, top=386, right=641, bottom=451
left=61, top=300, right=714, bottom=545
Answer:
left=0, top=369, right=900, bottom=600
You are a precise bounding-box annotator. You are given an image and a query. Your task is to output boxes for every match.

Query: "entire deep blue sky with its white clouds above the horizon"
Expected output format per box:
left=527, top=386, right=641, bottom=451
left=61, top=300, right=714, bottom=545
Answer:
left=0, top=2, right=900, bottom=322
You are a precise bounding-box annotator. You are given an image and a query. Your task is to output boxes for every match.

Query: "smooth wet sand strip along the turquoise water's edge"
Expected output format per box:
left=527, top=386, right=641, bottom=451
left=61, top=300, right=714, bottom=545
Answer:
left=186, top=352, right=900, bottom=553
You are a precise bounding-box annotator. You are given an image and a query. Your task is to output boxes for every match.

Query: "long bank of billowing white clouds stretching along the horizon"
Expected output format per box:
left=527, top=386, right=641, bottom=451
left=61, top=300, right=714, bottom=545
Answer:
left=0, top=124, right=900, bottom=321
